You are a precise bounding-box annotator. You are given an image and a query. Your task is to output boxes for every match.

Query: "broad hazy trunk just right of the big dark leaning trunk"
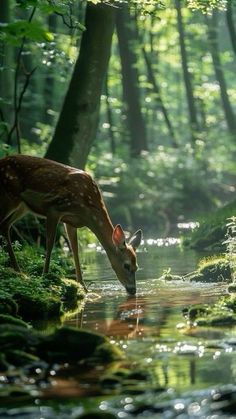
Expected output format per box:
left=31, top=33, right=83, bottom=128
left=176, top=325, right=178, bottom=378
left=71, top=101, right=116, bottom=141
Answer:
left=116, top=5, right=148, bottom=157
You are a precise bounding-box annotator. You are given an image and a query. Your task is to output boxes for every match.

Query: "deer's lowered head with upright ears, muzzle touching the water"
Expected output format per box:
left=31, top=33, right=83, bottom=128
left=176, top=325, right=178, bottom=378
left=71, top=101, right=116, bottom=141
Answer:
left=112, top=224, right=142, bottom=295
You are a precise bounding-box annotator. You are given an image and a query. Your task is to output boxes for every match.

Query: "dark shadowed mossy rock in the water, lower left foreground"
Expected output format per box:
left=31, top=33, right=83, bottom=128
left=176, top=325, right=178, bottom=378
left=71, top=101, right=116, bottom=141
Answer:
left=0, top=318, right=122, bottom=371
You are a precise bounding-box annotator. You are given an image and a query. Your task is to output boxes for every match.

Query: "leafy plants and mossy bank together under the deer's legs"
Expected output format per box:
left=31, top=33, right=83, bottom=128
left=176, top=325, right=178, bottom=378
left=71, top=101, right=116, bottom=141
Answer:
left=0, top=247, right=84, bottom=320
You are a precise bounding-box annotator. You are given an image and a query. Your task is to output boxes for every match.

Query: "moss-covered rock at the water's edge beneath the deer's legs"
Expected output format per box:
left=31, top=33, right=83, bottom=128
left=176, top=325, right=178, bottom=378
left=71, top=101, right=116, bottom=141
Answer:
left=0, top=260, right=85, bottom=320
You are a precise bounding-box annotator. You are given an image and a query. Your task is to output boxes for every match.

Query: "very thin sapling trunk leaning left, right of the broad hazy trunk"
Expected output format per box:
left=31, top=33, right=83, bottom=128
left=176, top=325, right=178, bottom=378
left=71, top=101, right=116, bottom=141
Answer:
left=142, top=47, right=178, bottom=148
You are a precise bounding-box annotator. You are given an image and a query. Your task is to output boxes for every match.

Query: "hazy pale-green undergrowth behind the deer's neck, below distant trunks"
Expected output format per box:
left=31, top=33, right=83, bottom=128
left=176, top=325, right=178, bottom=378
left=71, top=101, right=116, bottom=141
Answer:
left=91, top=146, right=221, bottom=233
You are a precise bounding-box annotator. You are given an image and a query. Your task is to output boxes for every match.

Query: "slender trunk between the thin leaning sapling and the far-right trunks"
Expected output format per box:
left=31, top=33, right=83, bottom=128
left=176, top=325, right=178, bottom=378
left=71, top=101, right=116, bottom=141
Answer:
left=175, top=0, right=199, bottom=142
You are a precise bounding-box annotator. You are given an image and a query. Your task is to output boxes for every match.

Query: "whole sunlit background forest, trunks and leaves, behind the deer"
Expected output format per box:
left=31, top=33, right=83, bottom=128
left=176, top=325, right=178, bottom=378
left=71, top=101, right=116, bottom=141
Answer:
left=0, top=0, right=236, bottom=235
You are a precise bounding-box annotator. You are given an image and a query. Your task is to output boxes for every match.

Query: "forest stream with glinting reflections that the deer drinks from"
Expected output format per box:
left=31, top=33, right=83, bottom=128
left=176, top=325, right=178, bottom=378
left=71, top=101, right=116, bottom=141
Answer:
left=0, top=244, right=236, bottom=419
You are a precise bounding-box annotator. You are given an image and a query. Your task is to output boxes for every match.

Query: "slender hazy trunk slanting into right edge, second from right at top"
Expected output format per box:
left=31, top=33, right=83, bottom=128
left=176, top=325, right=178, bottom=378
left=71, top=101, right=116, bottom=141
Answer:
left=206, top=10, right=236, bottom=134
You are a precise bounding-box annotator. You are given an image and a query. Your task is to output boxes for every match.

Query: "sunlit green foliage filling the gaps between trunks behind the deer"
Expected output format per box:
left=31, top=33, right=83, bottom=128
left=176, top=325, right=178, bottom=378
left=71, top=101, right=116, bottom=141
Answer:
left=0, top=0, right=236, bottom=234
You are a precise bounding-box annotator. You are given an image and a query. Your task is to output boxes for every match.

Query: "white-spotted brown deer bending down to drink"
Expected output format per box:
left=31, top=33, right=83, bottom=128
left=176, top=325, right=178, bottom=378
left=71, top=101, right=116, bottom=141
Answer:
left=0, top=154, right=142, bottom=295
